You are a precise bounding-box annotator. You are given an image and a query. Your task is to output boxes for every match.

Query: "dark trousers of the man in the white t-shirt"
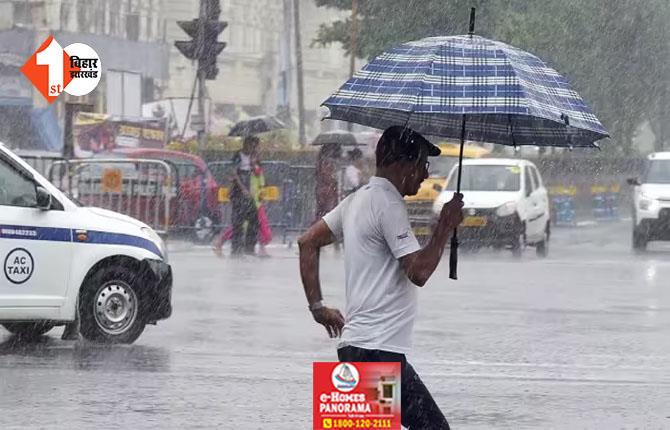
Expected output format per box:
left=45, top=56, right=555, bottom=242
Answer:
left=337, top=346, right=449, bottom=430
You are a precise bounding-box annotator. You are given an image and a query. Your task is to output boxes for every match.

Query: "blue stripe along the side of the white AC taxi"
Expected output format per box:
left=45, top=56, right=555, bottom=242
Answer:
left=0, top=225, right=163, bottom=258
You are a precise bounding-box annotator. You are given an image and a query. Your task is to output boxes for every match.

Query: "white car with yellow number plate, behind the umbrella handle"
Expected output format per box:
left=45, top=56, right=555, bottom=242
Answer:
left=433, top=158, right=551, bottom=257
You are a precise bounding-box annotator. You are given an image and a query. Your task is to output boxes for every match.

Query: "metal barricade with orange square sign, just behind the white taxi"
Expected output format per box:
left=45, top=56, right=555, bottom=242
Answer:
left=48, top=158, right=180, bottom=234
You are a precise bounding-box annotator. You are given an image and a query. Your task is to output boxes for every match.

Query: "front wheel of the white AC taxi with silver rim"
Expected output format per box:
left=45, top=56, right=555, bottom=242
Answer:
left=79, top=265, right=146, bottom=343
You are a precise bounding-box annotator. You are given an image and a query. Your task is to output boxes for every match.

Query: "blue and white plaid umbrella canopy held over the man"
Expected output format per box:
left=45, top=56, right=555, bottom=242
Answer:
left=323, top=35, right=609, bottom=147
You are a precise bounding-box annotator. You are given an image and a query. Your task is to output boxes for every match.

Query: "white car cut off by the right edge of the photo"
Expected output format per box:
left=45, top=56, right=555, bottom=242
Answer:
left=628, top=152, right=670, bottom=251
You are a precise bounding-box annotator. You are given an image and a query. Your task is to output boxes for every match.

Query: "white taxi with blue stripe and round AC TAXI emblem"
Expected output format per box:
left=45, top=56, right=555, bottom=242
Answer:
left=0, top=144, right=172, bottom=343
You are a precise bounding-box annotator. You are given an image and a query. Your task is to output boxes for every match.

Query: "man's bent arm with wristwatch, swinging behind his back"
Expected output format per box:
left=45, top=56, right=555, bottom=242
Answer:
left=298, top=220, right=344, bottom=337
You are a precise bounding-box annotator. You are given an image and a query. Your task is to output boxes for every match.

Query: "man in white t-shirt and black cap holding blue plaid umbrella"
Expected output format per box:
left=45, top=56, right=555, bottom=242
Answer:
left=299, top=9, right=608, bottom=430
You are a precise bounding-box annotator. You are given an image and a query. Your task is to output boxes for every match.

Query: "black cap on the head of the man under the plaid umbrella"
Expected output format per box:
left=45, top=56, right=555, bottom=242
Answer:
left=375, top=125, right=441, bottom=166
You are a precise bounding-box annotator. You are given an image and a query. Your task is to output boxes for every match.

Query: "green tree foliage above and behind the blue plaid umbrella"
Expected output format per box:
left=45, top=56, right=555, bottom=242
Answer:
left=314, top=0, right=670, bottom=152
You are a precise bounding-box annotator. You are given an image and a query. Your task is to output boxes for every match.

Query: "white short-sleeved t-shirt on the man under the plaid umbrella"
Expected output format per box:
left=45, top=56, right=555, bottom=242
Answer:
left=323, top=176, right=421, bottom=354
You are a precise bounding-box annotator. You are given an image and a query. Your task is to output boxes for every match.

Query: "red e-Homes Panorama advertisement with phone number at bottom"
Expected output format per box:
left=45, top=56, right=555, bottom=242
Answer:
left=313, top=363, right=401, bottom=430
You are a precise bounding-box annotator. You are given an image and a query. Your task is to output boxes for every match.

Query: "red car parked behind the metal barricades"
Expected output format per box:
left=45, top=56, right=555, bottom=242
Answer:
left=89, top=148, right=222, bottom=242
